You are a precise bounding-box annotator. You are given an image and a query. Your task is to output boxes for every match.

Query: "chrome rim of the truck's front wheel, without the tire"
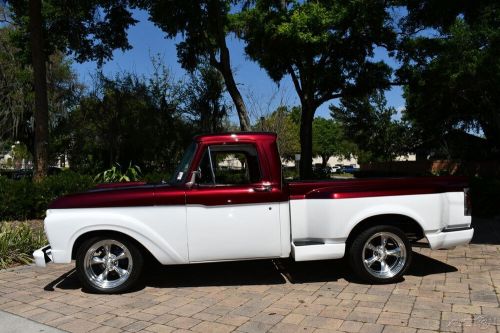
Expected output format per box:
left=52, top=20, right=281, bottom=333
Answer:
left=84, top=239, right=133, bottom=289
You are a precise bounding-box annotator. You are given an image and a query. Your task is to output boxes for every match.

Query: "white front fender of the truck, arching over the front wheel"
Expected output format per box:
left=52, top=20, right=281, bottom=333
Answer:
left=45, top=206, right=189, bottom=264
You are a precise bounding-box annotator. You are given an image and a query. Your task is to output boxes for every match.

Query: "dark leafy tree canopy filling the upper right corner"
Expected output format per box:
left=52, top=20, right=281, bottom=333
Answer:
left=398, top=0, right=500, bottom=158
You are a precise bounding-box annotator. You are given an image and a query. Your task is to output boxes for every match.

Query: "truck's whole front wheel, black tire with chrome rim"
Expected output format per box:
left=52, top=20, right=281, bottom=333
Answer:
left=76, top=236, right=144, bottom=294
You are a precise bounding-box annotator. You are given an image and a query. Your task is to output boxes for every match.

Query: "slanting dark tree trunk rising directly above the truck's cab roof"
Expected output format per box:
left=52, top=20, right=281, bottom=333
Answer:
left=218, top=36, right=251, bottom=131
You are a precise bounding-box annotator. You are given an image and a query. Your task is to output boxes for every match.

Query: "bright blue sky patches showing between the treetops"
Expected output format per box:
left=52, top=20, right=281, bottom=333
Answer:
left=73, top=10, right=404, bottom=123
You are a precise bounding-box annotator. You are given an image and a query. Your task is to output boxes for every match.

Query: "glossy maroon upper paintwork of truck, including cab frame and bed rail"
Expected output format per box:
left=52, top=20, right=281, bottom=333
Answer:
left=49, top=132, right=467, bottom=209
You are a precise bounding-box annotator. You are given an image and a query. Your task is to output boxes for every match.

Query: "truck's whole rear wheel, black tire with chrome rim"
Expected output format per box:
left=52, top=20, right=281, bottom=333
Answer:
left=348, top=225, right=412, bottom=283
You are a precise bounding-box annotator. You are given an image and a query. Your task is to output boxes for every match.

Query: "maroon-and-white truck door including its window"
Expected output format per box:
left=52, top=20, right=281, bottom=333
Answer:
left=186, top=143, right=282, bottom=262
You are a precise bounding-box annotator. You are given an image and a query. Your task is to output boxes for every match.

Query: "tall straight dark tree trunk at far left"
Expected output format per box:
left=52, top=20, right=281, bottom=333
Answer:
left=29, top=0, right=49, bottom=181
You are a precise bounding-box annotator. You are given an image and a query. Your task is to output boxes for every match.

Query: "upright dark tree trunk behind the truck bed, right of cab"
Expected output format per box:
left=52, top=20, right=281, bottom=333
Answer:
left=299, top=100, right=316, bottom=179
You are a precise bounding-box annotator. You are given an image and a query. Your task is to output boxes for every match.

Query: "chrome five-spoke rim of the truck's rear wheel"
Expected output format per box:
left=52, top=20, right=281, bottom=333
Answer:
left=361, top=231, right=407, bottom=279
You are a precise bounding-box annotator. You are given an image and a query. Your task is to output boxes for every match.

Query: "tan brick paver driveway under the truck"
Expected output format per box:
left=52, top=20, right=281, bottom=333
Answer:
left=0, top=217, right=500, bottom=333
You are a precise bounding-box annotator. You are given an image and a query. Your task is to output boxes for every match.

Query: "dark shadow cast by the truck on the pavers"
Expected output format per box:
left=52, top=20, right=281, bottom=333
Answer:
left=44, top=252, right=457, bottom=292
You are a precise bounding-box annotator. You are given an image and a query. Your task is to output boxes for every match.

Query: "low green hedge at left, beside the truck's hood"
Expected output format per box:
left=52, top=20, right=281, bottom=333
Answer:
left=0, top=171, right=94, bottom=220
